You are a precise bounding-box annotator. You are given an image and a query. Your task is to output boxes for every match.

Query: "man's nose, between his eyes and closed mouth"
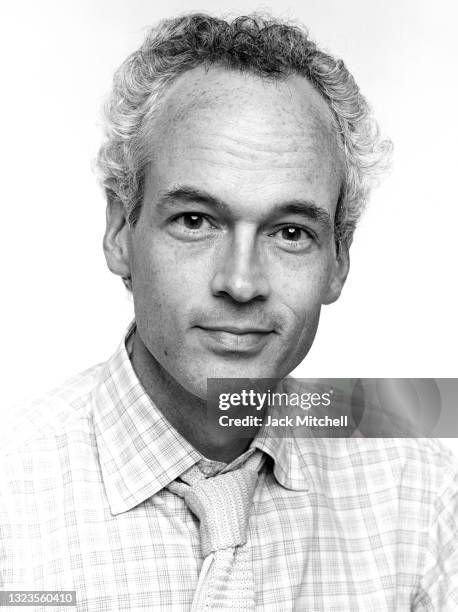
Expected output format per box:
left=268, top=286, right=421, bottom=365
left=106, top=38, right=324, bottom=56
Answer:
left=211, top=227, right=270, bottom=303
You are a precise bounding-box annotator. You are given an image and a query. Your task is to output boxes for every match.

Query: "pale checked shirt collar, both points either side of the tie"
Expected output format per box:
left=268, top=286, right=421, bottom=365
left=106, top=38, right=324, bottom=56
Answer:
left=92, top=321, right=310, bottom=514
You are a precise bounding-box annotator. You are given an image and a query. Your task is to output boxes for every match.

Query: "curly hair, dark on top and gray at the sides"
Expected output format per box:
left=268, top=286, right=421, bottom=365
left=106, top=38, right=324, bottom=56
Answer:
left=96, top=13, right=391, bottom=248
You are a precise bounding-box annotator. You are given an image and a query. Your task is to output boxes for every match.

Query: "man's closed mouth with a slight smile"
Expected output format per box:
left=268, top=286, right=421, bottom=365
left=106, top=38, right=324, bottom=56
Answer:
left=197, top=325, right=274, bottom=353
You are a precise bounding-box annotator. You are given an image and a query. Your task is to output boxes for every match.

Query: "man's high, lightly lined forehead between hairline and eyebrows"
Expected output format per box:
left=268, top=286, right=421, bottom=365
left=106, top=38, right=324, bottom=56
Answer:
left=145, top=67, right=342, bottom=214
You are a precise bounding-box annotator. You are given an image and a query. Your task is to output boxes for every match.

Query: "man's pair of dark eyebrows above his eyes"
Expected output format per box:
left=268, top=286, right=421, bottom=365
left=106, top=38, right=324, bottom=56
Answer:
left=157, top=185, right=333, bottom=232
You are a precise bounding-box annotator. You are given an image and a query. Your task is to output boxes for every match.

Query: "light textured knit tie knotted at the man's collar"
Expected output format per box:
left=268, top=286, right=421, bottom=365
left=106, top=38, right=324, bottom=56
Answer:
left=168, top=453, right=259, bottom=612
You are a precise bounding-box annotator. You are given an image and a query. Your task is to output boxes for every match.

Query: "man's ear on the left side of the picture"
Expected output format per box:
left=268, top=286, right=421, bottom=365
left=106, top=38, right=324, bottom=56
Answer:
left=103, top=199, right=130, bottom=278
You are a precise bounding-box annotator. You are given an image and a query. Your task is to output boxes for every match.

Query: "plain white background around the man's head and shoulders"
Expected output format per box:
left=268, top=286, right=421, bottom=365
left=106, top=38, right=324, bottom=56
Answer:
left=0, top=0, right=458, bottom=448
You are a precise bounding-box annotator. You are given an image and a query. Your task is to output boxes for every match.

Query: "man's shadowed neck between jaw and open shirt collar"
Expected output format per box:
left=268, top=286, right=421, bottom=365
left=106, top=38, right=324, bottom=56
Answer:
left=131, top=330, right=251, bottom=463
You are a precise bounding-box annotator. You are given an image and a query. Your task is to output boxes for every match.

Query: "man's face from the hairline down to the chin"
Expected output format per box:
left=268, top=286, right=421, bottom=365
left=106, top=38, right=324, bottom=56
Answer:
left=121, top=68, right=348, bottom=398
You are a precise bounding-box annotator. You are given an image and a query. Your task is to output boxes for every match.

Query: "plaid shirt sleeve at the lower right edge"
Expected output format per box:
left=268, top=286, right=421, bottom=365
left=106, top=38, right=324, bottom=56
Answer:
left=412, top=448, right=458, bottom=612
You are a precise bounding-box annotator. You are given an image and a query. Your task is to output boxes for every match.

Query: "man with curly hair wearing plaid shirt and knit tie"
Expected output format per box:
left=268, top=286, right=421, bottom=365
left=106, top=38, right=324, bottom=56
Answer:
left=0, top=14, right=458, bottom=611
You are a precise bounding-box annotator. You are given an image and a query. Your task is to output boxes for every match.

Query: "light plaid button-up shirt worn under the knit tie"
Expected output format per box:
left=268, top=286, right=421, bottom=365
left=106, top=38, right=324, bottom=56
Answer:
left=0, top=328, right=458, bottom=612
